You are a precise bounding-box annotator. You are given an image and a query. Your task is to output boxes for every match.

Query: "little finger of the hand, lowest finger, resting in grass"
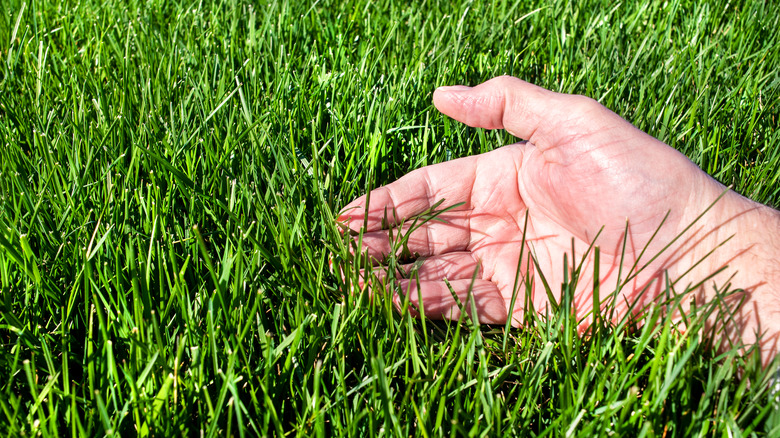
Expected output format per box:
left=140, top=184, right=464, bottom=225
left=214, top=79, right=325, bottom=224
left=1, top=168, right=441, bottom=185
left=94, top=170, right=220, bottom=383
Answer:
left=393, top=279, right=522, bottom=326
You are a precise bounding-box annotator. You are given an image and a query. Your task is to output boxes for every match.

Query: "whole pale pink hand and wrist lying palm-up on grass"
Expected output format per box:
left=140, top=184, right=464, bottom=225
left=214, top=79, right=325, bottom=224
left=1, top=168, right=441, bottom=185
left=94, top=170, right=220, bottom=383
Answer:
left=339, top=77, right=780, bottom=364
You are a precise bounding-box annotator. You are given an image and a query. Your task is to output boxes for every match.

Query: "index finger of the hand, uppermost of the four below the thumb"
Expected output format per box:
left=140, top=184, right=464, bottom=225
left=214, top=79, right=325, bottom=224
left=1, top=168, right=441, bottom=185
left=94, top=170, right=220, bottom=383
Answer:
left=337, top=157, right=477, bottom=231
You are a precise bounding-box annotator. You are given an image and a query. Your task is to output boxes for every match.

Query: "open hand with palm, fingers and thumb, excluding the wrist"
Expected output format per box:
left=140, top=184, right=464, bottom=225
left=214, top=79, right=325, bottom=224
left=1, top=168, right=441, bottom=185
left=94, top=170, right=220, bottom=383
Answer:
left=342, top=77, right=724, bottom=323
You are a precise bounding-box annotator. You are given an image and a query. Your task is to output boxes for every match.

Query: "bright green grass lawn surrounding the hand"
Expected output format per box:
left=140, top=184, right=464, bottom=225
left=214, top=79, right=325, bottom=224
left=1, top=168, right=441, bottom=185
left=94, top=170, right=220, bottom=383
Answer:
left=0, top=0, right=780, bottom=437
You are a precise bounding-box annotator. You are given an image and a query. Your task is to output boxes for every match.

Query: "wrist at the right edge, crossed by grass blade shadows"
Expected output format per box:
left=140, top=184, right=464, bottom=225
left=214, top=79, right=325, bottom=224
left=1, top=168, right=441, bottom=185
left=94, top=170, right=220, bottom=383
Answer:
left=677, top=191, right=780, bottom=364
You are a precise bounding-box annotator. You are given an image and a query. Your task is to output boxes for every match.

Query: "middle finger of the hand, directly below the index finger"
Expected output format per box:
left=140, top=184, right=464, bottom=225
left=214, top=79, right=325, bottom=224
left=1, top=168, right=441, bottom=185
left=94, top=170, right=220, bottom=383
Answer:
left=356, top=212, right=470, bottom=261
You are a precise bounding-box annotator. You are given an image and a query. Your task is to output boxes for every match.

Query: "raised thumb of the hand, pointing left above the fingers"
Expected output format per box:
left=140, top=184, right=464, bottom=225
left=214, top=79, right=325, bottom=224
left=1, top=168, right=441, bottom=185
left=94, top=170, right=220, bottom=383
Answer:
left=433, top=76, right=572, bottom=149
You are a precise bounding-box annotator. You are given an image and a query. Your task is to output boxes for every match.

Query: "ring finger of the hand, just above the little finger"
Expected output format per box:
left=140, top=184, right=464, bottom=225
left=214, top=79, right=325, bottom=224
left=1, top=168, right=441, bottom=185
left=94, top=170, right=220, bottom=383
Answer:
left=359, top=251, right=482, bottom=287
